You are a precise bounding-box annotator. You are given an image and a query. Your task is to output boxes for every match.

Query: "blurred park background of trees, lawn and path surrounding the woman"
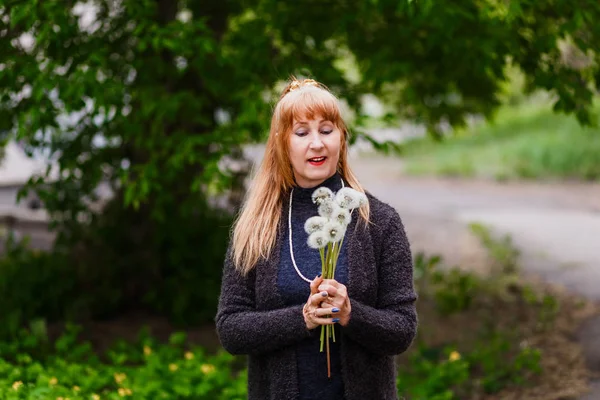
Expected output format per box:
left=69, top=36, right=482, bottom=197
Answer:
left=0, top=0, right=600, bottom=400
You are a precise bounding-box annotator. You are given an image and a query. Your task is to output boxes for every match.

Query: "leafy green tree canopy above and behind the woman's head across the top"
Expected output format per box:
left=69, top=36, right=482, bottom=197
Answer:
left=0, top=0, right=600, bottom=221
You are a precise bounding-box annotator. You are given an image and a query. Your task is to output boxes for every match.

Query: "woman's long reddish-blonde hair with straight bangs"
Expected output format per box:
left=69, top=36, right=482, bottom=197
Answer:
left=232, top=79, right=369, bottom=275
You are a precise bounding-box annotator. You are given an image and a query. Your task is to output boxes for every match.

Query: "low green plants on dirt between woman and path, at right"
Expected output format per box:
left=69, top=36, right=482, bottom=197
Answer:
left=408, top=252, right=558, bottom=400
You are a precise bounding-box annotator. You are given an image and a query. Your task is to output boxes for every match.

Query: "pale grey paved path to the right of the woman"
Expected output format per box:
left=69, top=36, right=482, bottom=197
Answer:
left=354, top=159, right=600, bottom=301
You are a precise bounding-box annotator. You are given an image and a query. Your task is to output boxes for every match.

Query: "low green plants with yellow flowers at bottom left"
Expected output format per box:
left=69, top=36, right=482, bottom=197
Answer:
left=0, top=329, right=247, bottom=400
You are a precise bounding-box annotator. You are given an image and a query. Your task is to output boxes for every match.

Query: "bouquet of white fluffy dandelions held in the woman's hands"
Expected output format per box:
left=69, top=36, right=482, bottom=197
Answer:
left=304, top=187, right=367, bottom=377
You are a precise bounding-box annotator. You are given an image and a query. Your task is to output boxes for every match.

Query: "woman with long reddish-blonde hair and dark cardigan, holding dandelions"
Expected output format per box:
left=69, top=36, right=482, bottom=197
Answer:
left=216, top=80, right=417, bottom=400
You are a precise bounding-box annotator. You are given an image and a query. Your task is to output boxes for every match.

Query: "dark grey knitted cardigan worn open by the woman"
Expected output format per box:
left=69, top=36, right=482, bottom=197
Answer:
left=215, top=194, right=417, bottom=400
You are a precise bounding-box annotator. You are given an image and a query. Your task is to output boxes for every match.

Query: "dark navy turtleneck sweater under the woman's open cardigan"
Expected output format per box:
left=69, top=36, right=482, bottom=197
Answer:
left=277, top=173, right=346, bottom=400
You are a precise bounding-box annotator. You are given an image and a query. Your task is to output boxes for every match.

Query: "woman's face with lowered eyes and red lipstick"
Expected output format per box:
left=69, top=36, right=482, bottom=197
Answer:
left=290, top=116, right=341, bottom=188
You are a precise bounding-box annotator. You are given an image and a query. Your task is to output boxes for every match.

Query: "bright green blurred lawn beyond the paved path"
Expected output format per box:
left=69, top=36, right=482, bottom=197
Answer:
left=403, top=98, right=600, bottom=180
